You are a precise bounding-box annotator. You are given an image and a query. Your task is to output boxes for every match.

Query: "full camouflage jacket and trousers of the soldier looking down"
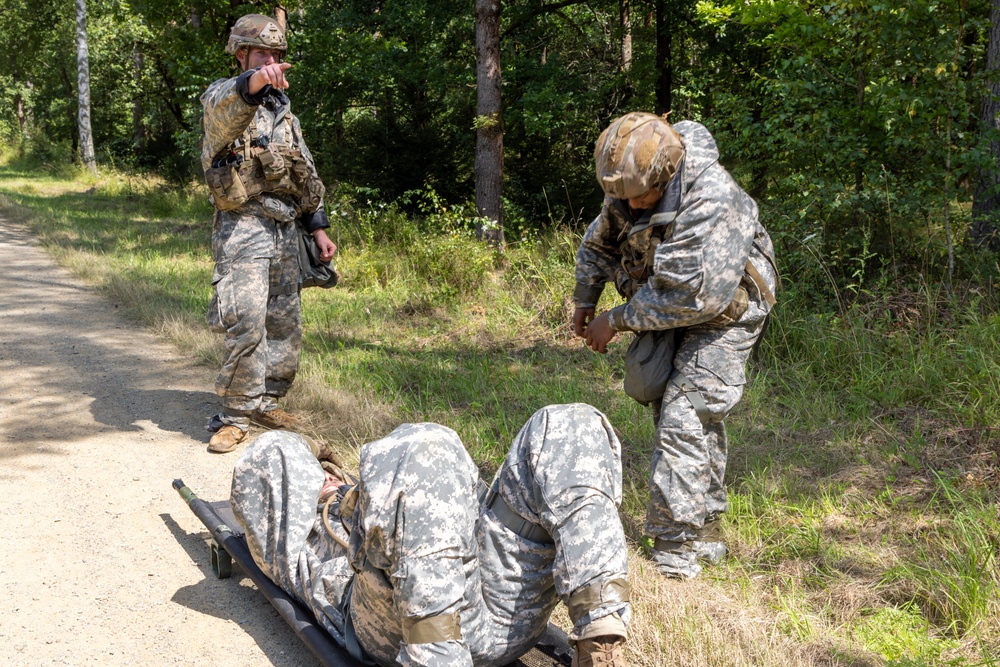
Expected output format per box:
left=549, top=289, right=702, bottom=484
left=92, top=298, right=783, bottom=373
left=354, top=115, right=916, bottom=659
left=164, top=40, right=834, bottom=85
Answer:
left=575, top=121, right=776, bottom=576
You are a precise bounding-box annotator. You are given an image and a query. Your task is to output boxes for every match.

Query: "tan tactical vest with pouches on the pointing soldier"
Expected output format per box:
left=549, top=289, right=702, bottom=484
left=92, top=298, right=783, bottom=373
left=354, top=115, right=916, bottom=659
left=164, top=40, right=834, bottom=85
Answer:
left=205, top=109, right=326, bottom=213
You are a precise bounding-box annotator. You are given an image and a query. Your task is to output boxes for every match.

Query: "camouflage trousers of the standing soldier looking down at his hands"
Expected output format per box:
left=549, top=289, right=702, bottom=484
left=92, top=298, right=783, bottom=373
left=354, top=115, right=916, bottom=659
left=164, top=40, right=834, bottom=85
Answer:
left=645, top=267, right=773, bottom=578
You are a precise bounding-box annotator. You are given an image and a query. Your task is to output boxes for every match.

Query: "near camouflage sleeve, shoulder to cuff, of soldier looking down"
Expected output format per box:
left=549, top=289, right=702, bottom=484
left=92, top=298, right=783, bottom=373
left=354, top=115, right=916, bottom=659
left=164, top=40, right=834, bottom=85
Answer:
left=610, top=162, right=757, bottom=331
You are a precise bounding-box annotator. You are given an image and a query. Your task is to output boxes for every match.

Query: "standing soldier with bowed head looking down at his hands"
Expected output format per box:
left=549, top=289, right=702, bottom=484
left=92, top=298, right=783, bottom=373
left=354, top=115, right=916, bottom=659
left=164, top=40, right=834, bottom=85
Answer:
left=573, top=113, right=777, bottom=578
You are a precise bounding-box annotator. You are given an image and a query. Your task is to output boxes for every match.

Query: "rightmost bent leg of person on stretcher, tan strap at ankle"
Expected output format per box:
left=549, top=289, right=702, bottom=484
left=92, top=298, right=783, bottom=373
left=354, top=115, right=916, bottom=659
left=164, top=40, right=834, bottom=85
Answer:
left=479, top=404, right=630, bottom=653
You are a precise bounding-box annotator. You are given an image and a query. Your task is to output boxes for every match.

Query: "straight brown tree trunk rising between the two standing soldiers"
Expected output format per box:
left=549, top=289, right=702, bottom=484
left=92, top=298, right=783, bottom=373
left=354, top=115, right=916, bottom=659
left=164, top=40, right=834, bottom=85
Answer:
left=475, top=0, right=504, bottom=248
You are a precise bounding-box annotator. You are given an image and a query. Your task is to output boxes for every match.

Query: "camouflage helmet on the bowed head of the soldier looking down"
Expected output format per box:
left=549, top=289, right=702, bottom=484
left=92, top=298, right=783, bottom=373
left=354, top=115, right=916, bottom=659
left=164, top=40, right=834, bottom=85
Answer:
left=594, top=112, right=684, bottom=199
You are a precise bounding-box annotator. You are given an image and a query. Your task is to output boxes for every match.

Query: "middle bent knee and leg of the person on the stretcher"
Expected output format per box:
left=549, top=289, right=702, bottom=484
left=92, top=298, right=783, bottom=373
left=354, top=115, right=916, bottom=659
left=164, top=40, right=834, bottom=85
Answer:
left=351, top=424, right=484, bottom=667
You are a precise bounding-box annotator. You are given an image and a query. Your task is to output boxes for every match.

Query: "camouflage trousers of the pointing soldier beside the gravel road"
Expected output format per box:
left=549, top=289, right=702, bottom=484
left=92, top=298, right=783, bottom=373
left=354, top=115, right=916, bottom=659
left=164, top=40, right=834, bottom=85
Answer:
left=209, top=202, right=302, bottom=430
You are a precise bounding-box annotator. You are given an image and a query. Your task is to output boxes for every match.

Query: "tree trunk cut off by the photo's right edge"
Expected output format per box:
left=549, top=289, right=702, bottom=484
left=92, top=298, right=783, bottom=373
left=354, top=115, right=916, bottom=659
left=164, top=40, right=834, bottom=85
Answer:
left=969, top=0, right=1000, bottom=251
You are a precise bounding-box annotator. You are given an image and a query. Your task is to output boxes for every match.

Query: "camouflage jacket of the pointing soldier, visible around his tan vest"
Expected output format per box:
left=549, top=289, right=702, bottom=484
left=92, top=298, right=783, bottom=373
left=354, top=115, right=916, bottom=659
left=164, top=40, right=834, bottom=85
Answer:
left=201, top=70, right=329, bottom=232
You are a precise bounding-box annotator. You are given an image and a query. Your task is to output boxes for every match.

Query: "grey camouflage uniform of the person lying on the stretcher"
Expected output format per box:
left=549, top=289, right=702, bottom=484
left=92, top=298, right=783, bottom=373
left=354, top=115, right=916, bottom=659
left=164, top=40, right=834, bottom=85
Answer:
left=231, top=404, right=630, bottom=667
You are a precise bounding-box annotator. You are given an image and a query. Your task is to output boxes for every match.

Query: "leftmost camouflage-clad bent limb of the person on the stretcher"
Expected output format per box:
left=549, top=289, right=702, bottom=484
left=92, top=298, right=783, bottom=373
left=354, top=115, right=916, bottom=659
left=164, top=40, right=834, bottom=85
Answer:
left=230, top=431, right=354, bottom=645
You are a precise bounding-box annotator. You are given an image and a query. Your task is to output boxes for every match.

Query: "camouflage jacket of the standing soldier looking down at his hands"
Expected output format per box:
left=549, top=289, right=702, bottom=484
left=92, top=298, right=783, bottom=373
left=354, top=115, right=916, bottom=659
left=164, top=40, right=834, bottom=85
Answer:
left=574, top=121, right=774, bottom=331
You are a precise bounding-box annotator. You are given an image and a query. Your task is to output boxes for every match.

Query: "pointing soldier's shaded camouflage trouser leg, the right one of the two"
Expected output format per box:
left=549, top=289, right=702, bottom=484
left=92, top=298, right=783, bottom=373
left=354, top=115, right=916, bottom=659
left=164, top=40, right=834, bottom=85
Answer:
left=260, top=223, right=302, bottom=412
